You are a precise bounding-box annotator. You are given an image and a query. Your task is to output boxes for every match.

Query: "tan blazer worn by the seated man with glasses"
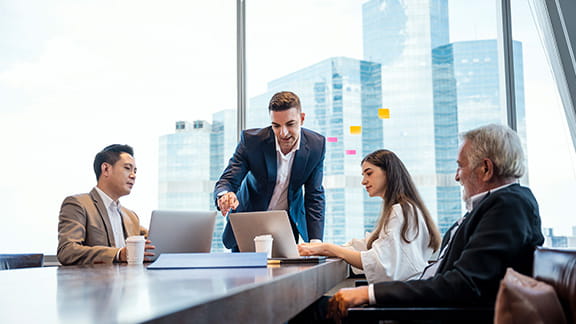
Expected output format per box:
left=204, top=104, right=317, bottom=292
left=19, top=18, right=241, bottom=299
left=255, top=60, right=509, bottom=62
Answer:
left=58, top=189, right=147, bottom=265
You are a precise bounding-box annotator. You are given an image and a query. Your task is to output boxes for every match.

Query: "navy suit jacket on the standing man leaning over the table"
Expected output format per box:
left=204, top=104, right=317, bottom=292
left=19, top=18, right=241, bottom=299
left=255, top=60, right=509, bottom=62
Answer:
left=214, top=126, right=326, bottom=249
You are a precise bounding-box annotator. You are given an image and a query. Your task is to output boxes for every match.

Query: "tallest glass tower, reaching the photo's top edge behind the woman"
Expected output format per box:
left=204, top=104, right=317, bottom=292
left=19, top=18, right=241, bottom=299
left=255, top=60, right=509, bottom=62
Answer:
left=362, top=0, right=455, bottom=229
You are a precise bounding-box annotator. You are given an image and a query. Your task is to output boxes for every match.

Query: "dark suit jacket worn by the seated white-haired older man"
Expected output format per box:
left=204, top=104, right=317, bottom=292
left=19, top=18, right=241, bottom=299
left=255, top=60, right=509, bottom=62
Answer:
left=374, top=184, right=544, bottom=306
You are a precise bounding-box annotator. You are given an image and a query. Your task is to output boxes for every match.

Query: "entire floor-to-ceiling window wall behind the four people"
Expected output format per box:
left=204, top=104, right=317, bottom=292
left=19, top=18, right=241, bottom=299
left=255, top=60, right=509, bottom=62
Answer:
left=0, top=0, right=576, bottom=254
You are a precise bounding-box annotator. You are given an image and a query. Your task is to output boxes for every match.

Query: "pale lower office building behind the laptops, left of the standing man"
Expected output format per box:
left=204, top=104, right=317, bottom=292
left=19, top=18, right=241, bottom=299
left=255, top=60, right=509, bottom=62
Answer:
left=158, top=115, right=236, bottom=252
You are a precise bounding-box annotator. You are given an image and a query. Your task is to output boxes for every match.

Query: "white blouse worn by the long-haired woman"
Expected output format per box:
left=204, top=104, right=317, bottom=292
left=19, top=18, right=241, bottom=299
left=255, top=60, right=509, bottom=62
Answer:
left=344, top=204, right=433, bottom=283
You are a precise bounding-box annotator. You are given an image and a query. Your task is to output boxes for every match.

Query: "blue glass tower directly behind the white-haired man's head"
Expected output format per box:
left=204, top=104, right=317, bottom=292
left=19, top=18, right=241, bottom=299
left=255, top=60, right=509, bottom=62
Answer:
left=432, top=40, right=527, bottom=232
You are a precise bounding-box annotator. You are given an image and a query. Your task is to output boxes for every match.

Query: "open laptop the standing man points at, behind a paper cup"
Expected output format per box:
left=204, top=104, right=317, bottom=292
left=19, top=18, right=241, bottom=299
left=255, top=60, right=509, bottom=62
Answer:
left=228, top=210, right=326, bottom=263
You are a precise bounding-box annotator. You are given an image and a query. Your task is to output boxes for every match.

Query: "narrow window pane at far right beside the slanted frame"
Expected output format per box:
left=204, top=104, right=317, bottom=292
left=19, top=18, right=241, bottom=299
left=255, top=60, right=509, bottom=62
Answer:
left=512, top=0, right=576, bottom=247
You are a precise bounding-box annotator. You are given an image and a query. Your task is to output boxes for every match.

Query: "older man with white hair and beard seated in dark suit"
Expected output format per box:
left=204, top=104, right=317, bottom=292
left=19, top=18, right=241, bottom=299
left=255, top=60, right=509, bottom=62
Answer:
left=329, top=125, right=544, bottom=317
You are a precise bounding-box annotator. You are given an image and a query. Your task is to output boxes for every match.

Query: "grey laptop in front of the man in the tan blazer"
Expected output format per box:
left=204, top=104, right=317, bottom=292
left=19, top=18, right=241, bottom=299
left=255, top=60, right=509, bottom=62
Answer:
left=148, top=210, right=216, bottom=261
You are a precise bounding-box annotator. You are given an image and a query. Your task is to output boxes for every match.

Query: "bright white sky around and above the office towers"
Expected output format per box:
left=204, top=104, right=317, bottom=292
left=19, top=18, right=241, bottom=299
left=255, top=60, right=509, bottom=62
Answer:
left=0, top=0, right=576, bottom=253
